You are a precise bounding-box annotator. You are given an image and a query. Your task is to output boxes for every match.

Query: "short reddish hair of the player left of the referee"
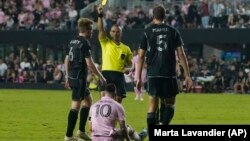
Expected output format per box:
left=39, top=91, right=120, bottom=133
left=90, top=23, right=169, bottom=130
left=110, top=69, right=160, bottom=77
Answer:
left=77, top=18, right=94, bottom=33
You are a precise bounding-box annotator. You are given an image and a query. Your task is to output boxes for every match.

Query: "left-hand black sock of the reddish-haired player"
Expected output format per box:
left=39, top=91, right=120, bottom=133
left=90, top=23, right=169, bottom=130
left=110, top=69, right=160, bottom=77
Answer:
left=66, top=109, right=78, bottom=137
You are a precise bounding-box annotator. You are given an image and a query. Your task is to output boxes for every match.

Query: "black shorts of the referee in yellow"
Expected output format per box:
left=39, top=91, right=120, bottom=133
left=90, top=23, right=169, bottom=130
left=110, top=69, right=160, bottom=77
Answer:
left=101, top=71, right=126, bottom=98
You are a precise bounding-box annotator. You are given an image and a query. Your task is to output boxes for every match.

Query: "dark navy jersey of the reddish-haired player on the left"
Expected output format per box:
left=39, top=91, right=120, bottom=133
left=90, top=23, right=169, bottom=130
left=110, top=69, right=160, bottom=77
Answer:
left=66, top=36, right=91, bottom=79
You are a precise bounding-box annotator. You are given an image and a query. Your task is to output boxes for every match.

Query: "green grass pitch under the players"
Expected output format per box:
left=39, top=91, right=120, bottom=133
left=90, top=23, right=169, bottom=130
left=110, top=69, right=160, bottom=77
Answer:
left=0, top=89, right=250, bottom=141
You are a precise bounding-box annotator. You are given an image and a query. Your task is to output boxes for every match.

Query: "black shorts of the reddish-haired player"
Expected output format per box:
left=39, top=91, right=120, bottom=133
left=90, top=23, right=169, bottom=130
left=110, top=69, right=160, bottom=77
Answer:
left=68, top=78, right=90, bottom=101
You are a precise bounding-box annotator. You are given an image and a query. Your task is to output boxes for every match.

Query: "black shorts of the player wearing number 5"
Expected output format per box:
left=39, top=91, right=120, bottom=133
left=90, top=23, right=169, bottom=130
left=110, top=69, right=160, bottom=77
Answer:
left=147, top=77, right=179, bottom=98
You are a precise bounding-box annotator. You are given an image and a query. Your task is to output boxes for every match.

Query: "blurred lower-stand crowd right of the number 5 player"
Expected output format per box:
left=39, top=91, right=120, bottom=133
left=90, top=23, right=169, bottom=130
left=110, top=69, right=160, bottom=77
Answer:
left=185, top=55, right=250, bottom=94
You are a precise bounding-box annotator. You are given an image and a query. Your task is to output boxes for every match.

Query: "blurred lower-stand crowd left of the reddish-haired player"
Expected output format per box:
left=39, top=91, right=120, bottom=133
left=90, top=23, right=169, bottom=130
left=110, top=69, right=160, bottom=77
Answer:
left=0, top=49, right=64, bottom=83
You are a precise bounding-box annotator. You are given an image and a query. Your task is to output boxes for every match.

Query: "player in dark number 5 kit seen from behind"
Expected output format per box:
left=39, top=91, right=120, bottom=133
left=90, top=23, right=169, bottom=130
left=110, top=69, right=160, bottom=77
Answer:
left=136, top=6, right=192, bottom=141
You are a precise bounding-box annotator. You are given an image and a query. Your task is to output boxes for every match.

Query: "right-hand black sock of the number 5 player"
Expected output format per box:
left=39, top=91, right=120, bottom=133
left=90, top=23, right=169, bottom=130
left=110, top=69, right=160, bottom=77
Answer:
left=162, top=104, right=174, bottom=125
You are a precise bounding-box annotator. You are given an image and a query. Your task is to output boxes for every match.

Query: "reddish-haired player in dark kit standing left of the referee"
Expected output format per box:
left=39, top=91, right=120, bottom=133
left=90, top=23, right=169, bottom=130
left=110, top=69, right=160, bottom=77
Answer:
left=64, top=18, right=106, bottom=141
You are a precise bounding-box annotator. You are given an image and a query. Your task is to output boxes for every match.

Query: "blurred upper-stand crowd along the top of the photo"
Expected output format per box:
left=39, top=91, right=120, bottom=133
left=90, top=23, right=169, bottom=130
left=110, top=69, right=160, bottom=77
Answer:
left=0, top=0, right=250, bottom=30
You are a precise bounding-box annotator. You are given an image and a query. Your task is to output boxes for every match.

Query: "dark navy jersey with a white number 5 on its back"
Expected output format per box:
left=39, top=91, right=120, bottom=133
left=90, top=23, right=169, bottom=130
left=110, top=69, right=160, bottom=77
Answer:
left=140, top=24, right=183, bottom=78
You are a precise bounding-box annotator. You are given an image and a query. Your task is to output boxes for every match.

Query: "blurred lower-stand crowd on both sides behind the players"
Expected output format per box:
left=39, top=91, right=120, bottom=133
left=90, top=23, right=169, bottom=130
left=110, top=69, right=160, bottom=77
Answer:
left=0, top=49, right=250, bottom=93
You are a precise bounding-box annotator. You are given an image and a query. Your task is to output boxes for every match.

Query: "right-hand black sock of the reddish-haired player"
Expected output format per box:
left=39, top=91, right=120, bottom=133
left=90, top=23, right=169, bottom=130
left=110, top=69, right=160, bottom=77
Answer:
left=79, top=107, right=90, bottom=132
